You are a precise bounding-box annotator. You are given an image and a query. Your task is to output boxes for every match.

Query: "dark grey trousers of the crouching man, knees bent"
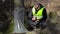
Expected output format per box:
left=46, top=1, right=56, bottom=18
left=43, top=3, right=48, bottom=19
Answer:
left=29, top=20, right=47, bottom=29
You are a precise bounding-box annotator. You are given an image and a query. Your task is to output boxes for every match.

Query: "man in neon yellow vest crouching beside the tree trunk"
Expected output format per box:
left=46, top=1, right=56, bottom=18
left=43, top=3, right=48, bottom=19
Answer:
left=28, top=2, right=47, bottom=29
